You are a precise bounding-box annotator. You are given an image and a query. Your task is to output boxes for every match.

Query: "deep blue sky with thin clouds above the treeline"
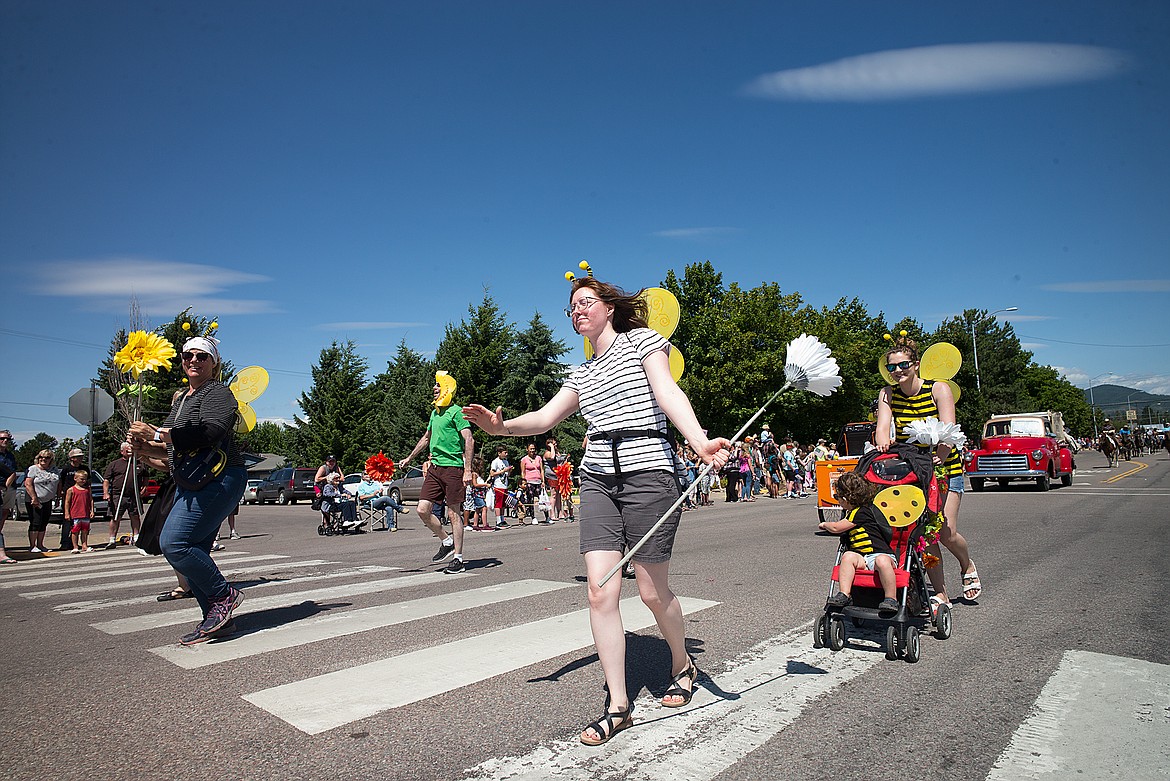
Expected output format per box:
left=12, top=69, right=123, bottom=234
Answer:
left=0, top=0, right=1170, bottom=438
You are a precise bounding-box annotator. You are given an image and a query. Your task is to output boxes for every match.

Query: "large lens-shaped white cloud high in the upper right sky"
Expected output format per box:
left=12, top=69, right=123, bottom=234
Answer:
left=742, top=42, right=1131, bottom=103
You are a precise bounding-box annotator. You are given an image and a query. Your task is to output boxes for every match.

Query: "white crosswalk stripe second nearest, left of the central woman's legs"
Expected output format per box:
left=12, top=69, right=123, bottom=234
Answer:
left=159, top=572, right=576, bottom=668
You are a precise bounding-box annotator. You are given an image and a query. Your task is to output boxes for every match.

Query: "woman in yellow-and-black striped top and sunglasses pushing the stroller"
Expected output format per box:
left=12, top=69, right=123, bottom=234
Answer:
left=874, top=337, right=983, bottom=610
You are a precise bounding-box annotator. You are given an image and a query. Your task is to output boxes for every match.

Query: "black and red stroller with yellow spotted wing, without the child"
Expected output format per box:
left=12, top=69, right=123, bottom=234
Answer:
left=813, top=443, right=951, bottom=663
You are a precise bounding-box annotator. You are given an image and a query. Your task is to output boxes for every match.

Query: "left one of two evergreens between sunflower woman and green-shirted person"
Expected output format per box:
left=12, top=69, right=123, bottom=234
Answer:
left=287, top=341, right=373, bottom=471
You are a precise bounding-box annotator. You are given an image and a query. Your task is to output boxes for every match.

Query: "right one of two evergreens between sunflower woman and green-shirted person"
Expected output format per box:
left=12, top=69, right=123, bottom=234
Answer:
left=366, top=339, right=435, bottom=462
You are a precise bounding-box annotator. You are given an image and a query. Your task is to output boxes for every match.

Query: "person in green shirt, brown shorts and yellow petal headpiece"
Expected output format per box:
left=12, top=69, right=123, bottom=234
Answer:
left=401, top=372, right=475, bottom=575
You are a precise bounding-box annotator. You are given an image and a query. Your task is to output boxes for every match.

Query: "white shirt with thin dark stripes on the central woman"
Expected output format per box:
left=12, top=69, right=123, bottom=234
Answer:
left=565, top=329, right=674, bottom=475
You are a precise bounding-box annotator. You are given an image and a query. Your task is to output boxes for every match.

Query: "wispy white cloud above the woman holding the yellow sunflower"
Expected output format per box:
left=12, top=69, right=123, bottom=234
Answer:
left=32, top=257, right=276, bottom=317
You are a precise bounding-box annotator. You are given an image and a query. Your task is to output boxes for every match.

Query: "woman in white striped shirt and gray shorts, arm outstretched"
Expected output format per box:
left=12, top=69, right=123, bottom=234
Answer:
left=463, top=277, right=731, bottom=746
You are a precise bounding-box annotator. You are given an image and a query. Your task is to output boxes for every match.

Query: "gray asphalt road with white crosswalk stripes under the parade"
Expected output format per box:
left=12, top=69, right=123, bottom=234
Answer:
left=0, top=452, right=1170, bottom=781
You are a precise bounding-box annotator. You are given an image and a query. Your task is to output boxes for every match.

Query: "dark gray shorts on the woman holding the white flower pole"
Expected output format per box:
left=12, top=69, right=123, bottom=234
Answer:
left=580, top=471, right=682, bottom=564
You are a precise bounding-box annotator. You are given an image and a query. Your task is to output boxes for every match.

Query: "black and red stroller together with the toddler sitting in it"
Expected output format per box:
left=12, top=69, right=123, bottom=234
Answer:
left=813, top=443, right=951, bottom=663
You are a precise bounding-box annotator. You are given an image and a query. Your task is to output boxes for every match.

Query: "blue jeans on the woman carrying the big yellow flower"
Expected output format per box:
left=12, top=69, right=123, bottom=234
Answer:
left=158, top=466, right=248, bottom=616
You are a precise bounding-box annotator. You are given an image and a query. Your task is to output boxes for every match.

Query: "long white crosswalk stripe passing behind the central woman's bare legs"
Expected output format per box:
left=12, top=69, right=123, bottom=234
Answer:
left=246, top=597, right=716, bottom=734
